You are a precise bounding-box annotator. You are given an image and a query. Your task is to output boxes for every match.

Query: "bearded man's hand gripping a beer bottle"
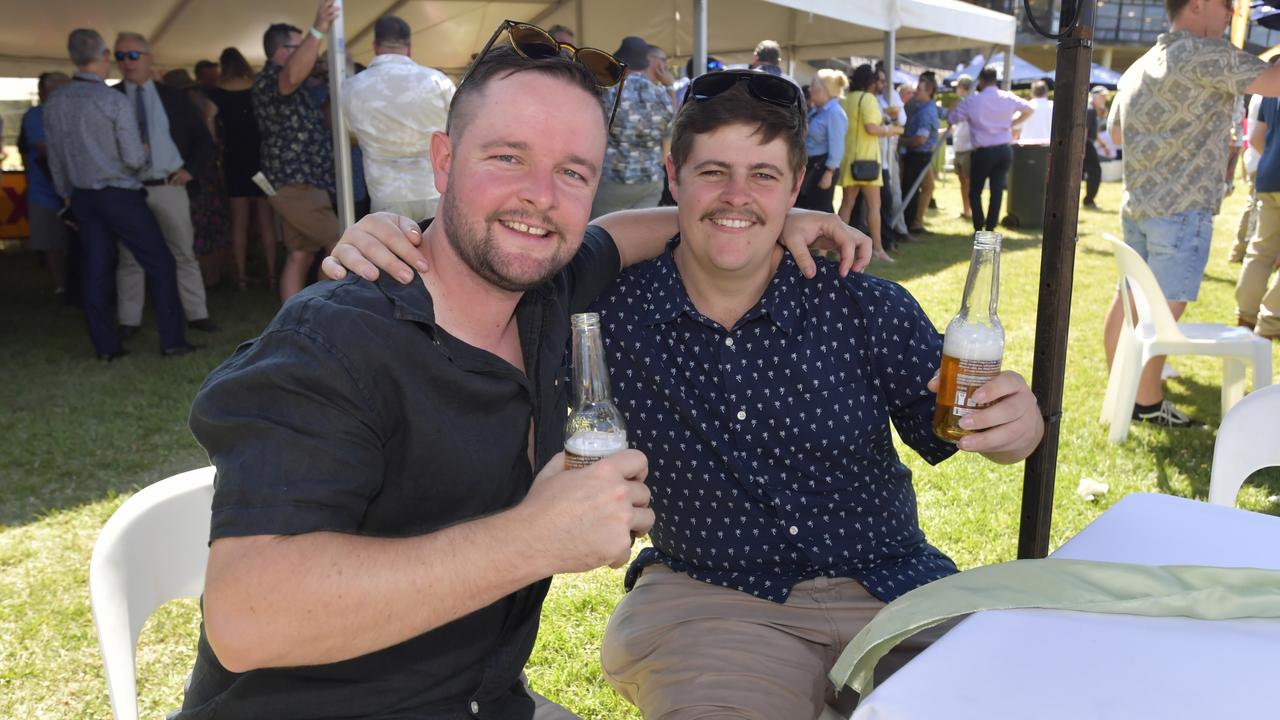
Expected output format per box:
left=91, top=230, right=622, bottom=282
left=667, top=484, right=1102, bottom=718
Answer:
left=520, top=450, right=654, bottom=573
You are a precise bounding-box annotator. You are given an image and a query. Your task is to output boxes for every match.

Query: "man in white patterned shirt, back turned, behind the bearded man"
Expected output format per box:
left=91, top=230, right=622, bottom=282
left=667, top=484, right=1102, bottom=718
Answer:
left=342, top=15, right=456, bottom=220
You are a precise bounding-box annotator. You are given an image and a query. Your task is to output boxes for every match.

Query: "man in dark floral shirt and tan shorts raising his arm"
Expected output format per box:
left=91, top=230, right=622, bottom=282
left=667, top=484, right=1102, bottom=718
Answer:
left=253, top=0, right=342, bottom=300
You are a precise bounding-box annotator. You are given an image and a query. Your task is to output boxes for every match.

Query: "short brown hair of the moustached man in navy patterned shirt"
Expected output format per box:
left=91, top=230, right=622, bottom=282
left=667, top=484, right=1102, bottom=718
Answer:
left=671, top=82, right=805, bottom=183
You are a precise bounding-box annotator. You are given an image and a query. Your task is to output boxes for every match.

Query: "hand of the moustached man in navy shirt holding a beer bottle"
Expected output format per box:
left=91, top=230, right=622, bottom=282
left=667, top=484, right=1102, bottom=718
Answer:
left=928, top=370, right=1044, bottom=464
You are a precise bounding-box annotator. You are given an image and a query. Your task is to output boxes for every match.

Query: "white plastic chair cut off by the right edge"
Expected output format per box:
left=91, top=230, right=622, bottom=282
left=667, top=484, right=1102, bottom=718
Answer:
left=1208, top=386, right=1280, bottom=507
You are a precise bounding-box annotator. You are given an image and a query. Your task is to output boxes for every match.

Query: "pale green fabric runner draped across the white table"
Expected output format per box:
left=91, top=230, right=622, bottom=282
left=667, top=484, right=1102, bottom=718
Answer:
left=829, top=559, right=1280, bottom=697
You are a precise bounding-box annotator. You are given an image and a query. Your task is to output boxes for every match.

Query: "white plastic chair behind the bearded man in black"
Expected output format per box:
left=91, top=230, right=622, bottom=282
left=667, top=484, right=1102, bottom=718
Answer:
left=88, top=468, right=214, bottom=720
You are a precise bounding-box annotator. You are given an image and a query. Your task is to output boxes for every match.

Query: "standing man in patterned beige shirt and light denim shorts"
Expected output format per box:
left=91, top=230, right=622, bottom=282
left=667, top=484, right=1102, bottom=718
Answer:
left=1103, top=0, right=1280, bottom=428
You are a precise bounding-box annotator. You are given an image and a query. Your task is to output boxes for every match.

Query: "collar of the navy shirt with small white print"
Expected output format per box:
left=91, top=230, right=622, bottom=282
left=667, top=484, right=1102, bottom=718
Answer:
left=639, top=234, right=804, bottom=336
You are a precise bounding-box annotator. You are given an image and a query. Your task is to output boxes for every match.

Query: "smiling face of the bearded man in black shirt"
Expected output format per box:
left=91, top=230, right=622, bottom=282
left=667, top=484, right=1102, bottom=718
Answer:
left=431, top=72, right=605, bottom=292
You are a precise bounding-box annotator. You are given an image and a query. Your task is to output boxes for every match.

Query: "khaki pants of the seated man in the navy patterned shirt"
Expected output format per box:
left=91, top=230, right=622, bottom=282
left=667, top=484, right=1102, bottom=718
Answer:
left=600, top=565, right=954, bottom=720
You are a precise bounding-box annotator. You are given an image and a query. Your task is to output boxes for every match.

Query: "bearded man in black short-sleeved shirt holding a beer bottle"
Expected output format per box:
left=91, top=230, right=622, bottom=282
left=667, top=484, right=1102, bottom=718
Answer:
left=178, top=26, right=851, bottom=720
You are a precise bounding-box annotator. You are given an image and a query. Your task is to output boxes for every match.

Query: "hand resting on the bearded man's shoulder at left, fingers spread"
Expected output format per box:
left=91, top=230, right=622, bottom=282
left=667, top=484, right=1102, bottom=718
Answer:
left=320, top=213, right=426, bottom=284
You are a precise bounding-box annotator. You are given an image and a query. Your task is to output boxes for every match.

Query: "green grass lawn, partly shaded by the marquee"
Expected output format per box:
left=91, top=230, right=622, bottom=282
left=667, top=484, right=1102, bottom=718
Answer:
left=0, top=175, right=1280, bottom=720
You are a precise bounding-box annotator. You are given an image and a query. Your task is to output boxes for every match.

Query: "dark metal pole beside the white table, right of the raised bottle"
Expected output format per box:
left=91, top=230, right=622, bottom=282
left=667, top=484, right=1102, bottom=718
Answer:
left=1018, top=0, right=1097, bottom=557
